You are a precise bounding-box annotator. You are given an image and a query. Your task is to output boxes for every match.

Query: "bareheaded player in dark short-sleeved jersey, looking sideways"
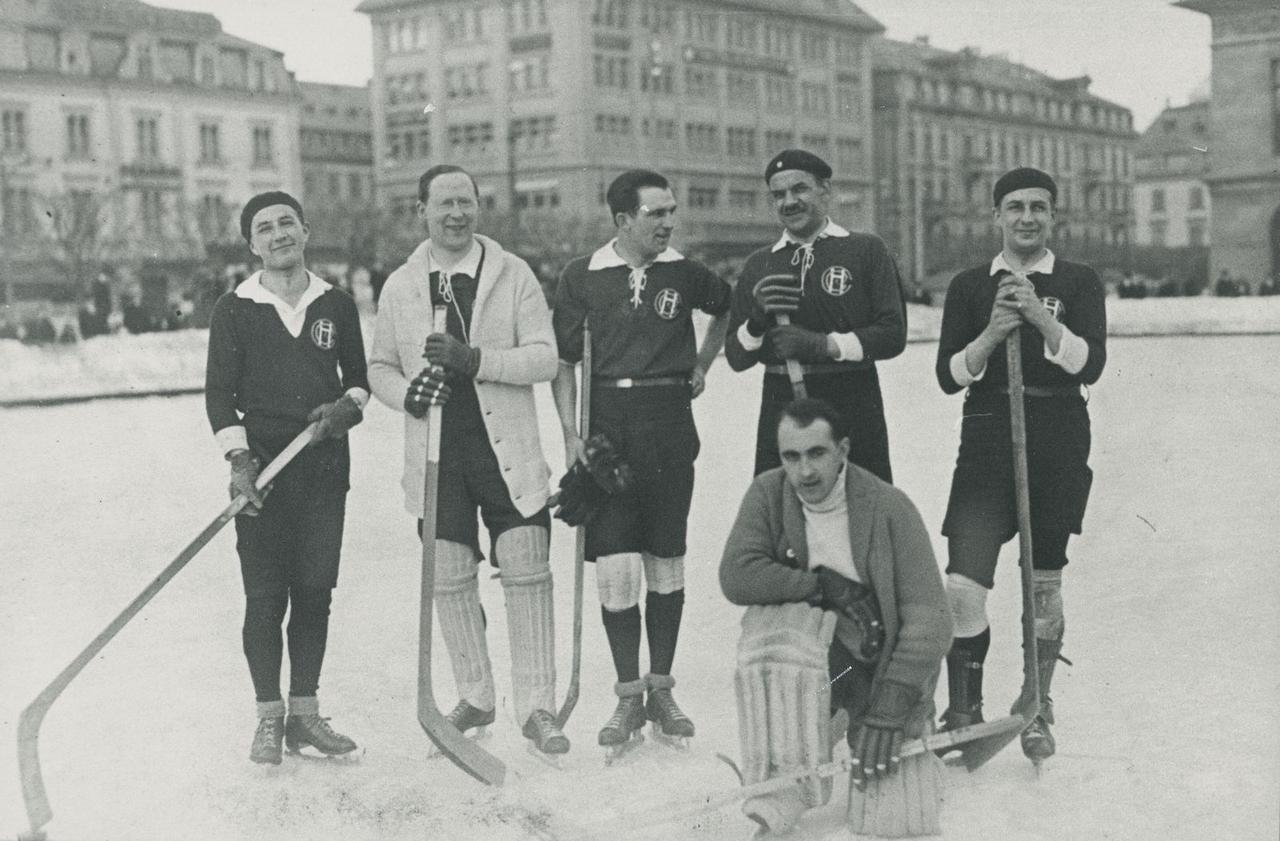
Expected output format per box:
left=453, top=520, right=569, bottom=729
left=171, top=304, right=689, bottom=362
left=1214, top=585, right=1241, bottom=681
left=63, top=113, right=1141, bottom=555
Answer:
left=552, top=170, right=730, bottom=750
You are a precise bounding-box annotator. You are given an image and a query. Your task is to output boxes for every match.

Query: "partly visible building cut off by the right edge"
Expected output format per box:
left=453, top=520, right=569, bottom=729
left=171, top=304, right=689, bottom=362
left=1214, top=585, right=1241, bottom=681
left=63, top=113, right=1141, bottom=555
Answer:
left=1175, top=0, right=1280, bottom=287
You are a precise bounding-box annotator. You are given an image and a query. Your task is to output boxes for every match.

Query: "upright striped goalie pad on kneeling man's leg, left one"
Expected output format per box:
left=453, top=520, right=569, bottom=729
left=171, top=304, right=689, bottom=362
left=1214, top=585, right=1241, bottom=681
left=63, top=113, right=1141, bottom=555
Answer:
left=733, top=603, right=836, bottom=806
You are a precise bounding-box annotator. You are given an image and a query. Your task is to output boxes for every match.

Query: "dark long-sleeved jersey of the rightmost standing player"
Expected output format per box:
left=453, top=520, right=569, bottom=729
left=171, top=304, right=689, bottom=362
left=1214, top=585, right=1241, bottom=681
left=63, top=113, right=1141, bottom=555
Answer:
left=937, top=259, right=1107, bottom=394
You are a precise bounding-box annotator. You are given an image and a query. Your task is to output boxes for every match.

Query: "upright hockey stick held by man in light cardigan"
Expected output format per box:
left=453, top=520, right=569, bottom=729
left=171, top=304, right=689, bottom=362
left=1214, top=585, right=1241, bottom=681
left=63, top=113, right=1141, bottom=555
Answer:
left=417, top=306, right=507, bottom=786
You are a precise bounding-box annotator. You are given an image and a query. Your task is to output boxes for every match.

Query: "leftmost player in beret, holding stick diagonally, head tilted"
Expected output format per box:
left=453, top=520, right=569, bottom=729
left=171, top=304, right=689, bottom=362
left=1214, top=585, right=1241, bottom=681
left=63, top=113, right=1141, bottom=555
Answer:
left=205, top=192, right=369, bottom=764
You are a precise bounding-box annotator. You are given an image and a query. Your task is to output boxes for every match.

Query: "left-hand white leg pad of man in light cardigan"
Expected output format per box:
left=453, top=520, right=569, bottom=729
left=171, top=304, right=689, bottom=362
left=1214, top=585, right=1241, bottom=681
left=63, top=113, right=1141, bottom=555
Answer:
left=435, top=540, right=495, bottom=709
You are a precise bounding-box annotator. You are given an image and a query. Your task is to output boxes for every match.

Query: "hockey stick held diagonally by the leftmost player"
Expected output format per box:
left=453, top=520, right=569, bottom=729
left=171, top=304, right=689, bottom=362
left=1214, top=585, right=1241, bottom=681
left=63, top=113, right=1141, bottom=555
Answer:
left=18, top=421, right=319, bottom=841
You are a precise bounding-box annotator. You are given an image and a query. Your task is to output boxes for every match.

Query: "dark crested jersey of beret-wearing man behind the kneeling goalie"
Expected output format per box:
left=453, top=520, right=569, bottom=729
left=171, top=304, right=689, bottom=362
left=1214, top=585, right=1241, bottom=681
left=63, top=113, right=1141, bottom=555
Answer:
left=726, top=227, right=906, bottom=370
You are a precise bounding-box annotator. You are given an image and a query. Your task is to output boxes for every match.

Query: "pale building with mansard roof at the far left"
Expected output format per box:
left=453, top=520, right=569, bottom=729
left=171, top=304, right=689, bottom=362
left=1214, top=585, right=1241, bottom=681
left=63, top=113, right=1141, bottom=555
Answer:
left=0, top=0, right=302, bottom=308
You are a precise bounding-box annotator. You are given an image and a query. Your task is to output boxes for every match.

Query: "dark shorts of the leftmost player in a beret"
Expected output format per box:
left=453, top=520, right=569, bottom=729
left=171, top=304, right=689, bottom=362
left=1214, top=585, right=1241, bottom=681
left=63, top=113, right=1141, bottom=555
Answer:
left=236, top=439, right=351, bottom=595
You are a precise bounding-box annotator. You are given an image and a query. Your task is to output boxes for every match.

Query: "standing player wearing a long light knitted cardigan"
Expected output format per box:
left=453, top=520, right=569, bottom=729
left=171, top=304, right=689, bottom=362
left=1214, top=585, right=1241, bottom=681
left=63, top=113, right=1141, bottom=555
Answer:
left=369, top=164, right=570, bottom=754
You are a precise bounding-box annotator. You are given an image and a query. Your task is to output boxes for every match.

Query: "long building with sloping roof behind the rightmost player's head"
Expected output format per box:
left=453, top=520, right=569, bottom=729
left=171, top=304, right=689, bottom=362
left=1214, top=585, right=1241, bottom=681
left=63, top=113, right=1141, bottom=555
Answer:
left=873, top=38, right=1135, bottom=282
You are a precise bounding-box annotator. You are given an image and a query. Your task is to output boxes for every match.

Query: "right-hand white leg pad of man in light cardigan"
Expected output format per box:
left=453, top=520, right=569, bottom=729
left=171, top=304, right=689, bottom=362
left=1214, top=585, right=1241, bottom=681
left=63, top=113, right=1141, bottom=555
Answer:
left=497, top=526, right=556, bottom=725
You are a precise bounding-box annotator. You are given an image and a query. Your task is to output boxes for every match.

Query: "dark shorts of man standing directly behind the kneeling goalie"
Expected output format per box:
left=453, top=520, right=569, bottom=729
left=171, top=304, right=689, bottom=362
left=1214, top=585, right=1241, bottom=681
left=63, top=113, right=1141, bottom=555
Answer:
left=755, top=367, right=893, bottom=483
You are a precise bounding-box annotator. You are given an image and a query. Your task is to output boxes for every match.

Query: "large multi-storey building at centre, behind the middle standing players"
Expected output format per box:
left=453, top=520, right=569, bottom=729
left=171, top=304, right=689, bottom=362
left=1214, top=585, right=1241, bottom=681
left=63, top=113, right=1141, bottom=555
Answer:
left=358, top=0, right=882, bottom=252
